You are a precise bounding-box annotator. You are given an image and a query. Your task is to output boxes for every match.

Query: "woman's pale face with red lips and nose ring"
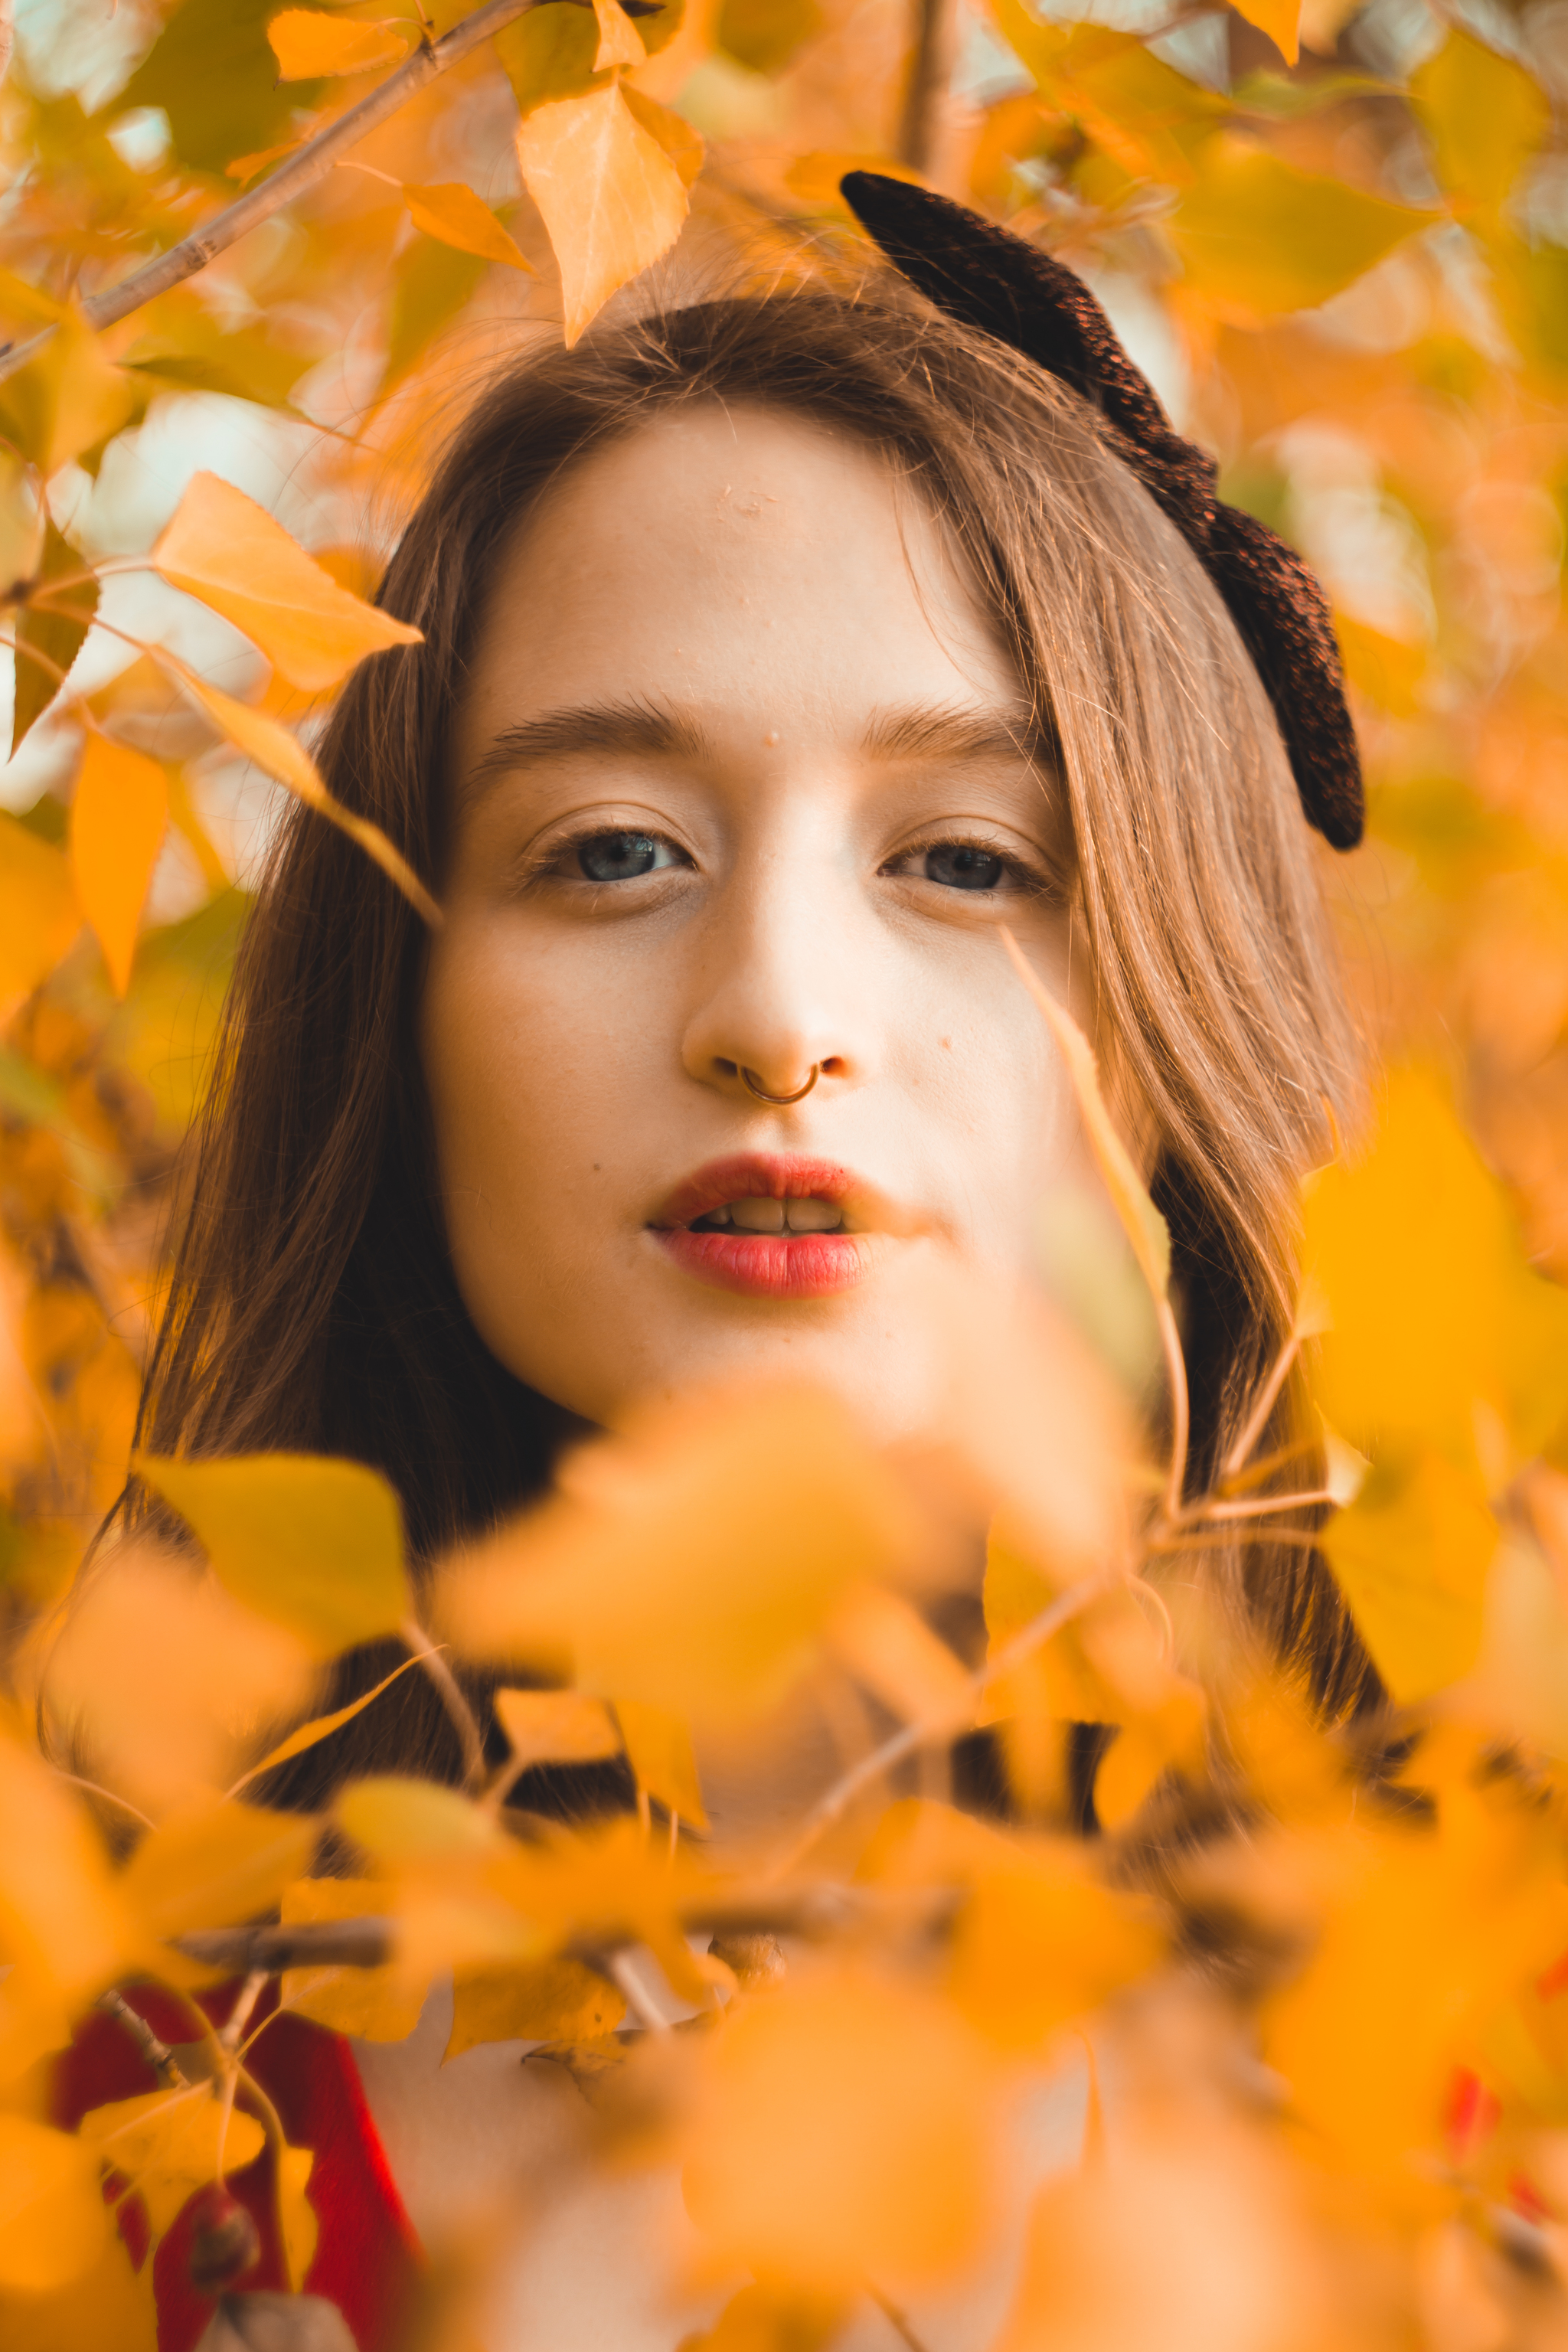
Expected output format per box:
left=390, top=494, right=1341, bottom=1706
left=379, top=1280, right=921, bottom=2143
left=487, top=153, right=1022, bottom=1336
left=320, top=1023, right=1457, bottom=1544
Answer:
left=421, top=402, right=1099, bottom=1439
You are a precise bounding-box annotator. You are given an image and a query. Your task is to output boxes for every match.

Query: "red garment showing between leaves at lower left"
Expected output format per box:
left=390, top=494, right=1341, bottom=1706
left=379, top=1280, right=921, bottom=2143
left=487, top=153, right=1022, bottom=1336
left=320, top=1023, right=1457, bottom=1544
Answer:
left=54, top=1985, right=421, bottom=2352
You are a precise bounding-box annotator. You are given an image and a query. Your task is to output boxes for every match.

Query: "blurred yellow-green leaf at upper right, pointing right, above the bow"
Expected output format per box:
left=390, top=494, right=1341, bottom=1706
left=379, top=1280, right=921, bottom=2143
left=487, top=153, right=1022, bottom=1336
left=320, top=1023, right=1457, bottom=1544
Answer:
left=1168, top=132, right=1436, bottom=322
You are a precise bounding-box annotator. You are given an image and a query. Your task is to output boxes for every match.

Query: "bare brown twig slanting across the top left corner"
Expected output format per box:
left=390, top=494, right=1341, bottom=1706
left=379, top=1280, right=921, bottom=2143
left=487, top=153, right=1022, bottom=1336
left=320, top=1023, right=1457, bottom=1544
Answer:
left=0, top=0, right=536, bottom=384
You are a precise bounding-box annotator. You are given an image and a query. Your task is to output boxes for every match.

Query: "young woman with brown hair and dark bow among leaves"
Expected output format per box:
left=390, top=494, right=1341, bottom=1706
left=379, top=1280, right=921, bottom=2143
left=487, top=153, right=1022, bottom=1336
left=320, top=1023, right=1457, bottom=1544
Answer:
left=70, top=176, right=1364, bottom=2352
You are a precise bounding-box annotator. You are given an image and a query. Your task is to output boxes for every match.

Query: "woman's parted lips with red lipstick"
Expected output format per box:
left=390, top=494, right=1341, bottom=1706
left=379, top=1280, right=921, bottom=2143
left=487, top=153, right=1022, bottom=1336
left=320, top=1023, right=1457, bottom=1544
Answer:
left=648, top=1152, right=881, bottom=1298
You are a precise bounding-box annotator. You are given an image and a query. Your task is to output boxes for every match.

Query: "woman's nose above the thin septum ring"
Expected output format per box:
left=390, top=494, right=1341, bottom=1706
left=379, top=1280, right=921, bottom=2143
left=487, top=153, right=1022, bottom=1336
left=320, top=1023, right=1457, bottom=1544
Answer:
left=681, top=858, right=872, bottom=1108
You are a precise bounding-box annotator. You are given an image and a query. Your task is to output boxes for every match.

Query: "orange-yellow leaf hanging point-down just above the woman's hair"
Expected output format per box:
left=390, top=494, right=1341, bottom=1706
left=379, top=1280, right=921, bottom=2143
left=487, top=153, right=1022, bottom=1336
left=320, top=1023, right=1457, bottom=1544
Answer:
left=518, top=83, right=687, bottom=346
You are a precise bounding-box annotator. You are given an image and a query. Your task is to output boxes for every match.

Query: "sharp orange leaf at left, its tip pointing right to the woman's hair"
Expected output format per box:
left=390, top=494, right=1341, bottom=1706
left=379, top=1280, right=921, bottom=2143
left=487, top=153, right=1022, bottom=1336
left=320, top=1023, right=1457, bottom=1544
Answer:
left=151, top=468, right=423, bottom=687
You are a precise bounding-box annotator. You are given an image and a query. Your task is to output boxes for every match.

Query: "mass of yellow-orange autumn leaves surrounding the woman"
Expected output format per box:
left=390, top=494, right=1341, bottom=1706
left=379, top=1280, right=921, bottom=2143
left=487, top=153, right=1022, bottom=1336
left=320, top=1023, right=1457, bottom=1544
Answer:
left=0, top=0, right=1568, bottom=2352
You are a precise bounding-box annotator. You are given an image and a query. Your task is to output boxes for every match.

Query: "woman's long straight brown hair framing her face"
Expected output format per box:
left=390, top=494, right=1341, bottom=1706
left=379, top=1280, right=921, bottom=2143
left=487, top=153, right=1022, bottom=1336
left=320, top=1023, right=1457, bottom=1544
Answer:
left=141, top=283, right=1366, bottom=1778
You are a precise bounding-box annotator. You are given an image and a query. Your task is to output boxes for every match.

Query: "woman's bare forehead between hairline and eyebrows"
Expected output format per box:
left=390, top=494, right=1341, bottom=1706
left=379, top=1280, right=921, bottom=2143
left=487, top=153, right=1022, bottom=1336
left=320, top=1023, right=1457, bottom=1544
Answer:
left=461, top=402, right=1021, bottom=762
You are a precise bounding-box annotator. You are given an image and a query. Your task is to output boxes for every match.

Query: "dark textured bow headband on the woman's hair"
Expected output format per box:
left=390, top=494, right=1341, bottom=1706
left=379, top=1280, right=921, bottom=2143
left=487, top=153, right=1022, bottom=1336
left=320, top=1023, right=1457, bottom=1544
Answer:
left=839, top=172, right=1366, bottom=849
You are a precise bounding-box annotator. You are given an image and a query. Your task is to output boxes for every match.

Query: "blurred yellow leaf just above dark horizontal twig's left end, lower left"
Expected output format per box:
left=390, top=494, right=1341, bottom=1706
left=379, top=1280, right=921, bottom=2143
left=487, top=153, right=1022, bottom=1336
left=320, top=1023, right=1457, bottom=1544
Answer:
left=120, top=1802, right=320, bottom=1942
